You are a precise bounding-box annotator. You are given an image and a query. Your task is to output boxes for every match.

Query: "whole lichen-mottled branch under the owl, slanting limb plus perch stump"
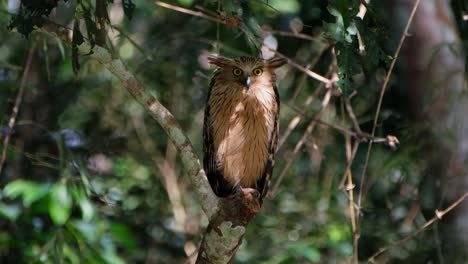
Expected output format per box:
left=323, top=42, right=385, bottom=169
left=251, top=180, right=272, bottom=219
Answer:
left=38, top=20, right=261, bottom=264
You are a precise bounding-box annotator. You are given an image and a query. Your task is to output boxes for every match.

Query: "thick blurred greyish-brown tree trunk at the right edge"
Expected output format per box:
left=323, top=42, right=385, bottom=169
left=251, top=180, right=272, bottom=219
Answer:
left=390, top=0, right=468, bottom=263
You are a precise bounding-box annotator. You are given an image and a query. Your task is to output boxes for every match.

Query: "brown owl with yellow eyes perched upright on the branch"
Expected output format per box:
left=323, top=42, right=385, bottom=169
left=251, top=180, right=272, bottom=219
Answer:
left=203, top=56, right=286, bottom=200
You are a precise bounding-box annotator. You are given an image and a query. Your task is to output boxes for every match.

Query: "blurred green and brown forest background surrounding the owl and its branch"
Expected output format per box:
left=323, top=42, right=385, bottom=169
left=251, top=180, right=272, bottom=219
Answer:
left=0, top=0, right=468, bottom=263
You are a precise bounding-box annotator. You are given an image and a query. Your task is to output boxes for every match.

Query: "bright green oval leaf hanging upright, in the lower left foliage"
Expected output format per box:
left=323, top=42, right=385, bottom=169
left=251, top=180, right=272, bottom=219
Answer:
left=49, top=183, right=72, bottom=225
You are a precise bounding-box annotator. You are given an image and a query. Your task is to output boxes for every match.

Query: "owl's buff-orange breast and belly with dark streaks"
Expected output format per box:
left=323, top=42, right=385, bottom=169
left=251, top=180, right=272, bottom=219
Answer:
left=209, top=78, right=278, bottom=188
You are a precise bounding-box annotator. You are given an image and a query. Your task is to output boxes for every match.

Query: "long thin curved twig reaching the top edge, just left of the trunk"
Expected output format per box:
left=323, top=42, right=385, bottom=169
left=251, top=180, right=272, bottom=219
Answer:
left=358, top=0, right=421, bottom=212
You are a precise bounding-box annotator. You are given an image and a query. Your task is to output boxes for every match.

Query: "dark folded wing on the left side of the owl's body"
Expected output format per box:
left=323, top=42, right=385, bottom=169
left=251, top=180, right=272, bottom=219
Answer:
left=203, top=78, right=234, bottom=197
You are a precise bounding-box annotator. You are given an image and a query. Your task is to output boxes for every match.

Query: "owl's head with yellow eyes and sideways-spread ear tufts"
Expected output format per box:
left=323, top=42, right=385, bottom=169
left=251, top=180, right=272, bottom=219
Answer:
left=208, top=55, right=286, bottom=89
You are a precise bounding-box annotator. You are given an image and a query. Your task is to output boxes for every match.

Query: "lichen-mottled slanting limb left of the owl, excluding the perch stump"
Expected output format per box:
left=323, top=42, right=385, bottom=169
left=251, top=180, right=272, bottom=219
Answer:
left=37, top=20, right=219, bottom=219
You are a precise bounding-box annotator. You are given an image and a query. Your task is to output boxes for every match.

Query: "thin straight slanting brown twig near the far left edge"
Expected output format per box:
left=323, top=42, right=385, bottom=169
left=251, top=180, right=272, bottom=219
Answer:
left=0, top=42, right=36, bottom=175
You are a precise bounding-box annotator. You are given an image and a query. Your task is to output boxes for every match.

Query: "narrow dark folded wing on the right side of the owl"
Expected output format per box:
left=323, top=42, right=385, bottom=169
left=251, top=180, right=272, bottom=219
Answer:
left=257, top=84, right=280, bottom=198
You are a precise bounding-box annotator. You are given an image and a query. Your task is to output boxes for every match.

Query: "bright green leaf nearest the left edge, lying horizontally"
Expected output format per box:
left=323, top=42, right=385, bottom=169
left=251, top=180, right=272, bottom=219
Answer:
left=3, top=180, right=50, bottom=207
